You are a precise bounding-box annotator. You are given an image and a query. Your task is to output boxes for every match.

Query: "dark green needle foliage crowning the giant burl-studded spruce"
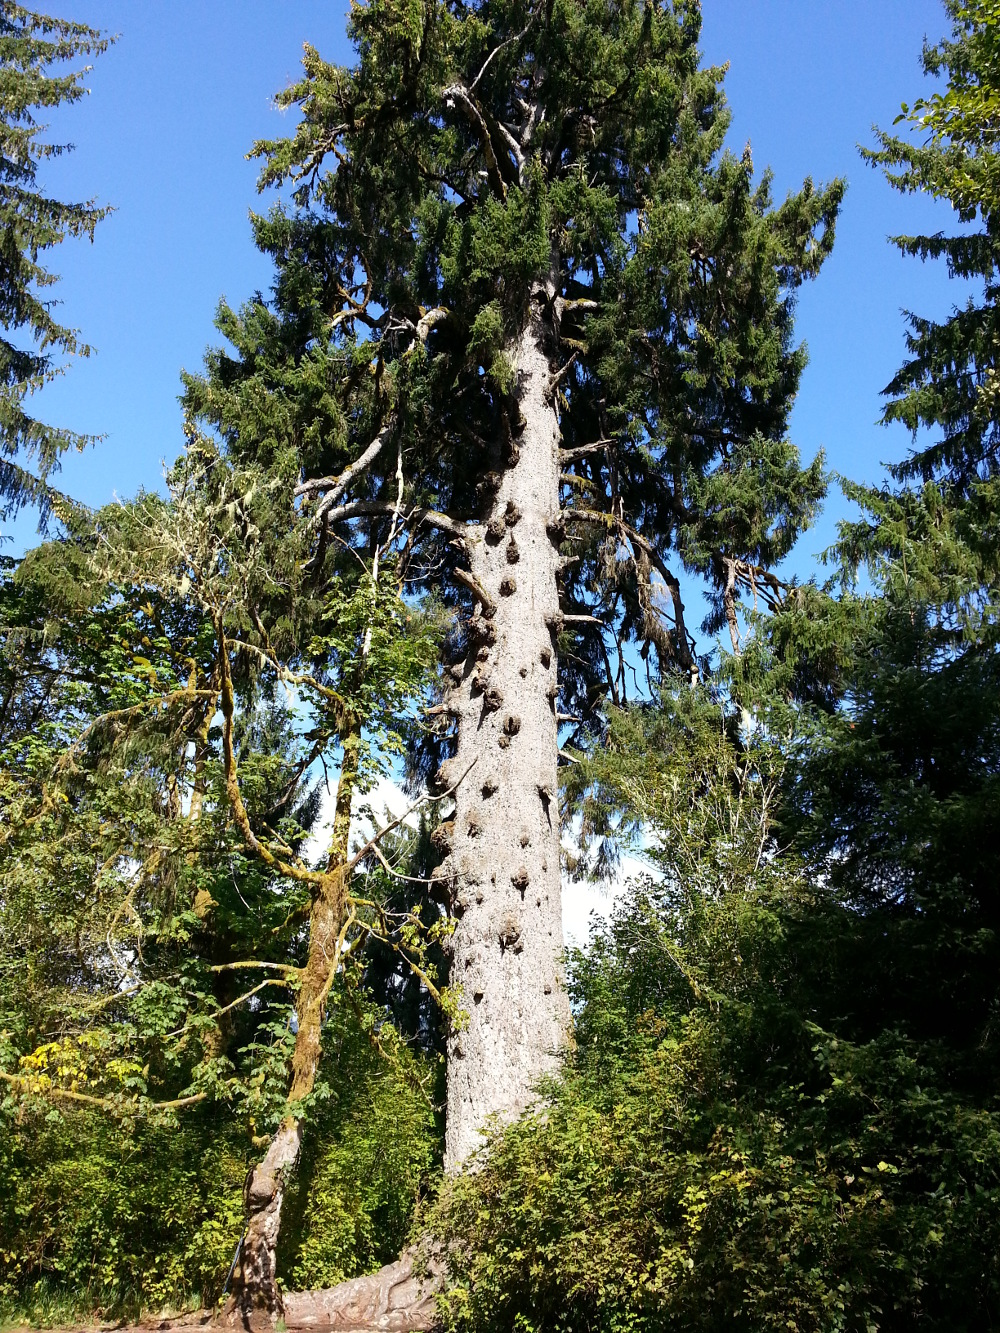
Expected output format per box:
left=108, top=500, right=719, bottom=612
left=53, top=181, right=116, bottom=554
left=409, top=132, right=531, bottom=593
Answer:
left=245, top=0, right=843, bottom=672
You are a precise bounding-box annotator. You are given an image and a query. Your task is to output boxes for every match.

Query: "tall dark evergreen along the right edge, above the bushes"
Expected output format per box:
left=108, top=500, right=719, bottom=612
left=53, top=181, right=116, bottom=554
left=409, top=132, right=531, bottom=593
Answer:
left=768, top=0, right=1000, bottom=1071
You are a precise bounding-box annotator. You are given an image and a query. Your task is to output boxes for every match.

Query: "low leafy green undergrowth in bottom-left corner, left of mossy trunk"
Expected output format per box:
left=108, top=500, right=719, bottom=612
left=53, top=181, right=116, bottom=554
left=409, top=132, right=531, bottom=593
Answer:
left=0, top=1109, right=247, bottom=1326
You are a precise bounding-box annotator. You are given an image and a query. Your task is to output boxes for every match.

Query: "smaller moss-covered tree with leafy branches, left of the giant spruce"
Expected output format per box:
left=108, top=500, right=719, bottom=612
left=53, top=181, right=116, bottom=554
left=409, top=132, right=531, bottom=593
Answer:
left=0, top=447, right=447, bottom=1322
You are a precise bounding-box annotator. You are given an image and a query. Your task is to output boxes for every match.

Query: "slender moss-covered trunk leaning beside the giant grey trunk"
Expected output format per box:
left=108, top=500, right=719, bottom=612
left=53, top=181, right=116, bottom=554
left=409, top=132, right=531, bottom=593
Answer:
left=227, top=730, right=360, bottom=1333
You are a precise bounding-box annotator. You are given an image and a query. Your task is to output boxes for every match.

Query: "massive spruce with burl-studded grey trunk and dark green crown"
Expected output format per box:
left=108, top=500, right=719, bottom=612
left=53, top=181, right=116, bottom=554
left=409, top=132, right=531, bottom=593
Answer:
left=188, top=0, right=841, bottom=1189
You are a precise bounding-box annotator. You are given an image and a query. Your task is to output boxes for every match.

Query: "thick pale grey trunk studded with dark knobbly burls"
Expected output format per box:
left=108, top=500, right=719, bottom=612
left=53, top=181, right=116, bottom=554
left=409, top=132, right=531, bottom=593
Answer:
left=439, top=287, right=569, bottom=1172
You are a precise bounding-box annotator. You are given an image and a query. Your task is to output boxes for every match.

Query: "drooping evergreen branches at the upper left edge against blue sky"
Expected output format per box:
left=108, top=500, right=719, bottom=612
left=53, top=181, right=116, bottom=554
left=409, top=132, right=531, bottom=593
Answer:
left=0, top=4, right=108, bottom=520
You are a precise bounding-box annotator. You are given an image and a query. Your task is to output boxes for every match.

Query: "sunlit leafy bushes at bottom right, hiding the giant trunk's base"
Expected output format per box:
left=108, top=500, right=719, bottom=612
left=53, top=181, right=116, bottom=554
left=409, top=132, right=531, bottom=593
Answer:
left=432, top=874, right=1000, bottom=1333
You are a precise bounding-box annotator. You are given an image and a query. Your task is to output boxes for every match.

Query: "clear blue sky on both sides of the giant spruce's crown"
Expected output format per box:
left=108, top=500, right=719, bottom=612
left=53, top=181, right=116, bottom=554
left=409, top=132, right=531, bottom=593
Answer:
left=0, top=0, right=959, bottom=573
